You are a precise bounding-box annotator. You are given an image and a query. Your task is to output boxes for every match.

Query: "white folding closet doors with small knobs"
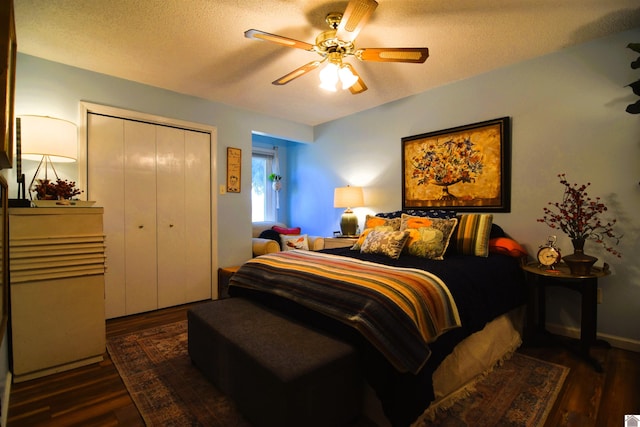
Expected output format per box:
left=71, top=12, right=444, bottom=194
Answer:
left=87, top=114, right=212, bottom=318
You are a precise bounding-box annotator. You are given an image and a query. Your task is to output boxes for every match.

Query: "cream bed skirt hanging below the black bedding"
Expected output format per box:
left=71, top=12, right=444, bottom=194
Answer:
left=363, top=306, right=525, bottom=427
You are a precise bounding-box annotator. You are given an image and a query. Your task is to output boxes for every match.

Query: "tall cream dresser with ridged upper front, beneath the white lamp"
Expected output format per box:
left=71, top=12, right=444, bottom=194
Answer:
left=9, top=207, right=105, bottom=382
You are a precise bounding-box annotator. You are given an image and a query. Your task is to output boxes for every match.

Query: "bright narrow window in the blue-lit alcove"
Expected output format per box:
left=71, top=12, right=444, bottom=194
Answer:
left=251, top=148, right=277, bottom=222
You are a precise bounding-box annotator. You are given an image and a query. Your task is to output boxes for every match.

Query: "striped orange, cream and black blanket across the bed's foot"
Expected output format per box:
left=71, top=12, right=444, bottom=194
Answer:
left=229, top=250, right=460, bottom=373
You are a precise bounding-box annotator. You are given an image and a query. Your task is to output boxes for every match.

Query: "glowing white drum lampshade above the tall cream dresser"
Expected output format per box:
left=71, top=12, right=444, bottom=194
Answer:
left=20, top=116, right=78, bottom=162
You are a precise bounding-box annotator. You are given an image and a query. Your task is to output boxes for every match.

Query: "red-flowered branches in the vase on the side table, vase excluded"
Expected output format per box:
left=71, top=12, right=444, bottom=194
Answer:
left=538, top=174, right=622, bottom=258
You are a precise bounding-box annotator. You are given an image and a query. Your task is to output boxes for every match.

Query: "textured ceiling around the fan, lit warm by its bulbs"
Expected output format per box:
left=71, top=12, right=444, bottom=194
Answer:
left=14, top=0, right=640, bottom=125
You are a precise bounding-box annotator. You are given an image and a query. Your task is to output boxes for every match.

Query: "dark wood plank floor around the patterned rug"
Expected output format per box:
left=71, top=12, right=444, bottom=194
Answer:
left=9, top=305, right=640, bottom=427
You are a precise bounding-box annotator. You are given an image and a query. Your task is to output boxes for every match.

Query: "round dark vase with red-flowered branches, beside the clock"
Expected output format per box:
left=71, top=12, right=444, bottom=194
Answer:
left=538, top=174, right=622, bottom=276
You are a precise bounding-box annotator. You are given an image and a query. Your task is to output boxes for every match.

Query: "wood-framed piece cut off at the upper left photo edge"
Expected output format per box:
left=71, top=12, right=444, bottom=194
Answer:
left=0, top=0, right=17, bottom=169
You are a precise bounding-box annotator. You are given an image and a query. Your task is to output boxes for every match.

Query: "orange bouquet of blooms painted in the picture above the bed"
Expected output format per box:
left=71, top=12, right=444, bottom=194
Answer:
left=412, top=137, right=484, bottom=189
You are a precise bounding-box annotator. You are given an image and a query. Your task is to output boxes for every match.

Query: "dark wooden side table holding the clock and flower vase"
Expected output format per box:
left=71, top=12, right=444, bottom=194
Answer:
left=522, top=262, right=611, bottom=372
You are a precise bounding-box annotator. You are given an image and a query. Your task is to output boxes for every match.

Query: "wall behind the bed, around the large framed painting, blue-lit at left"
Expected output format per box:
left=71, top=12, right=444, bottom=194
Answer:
left=289, top=29, right=640, bottom=351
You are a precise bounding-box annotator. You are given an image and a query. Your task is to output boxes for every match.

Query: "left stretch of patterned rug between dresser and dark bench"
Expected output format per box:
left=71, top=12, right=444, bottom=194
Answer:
left=107, top=321, right=249, bottom=427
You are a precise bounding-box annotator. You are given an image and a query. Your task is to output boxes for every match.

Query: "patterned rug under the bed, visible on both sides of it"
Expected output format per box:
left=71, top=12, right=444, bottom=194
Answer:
left=107, top=321, right=569, bottom=427
